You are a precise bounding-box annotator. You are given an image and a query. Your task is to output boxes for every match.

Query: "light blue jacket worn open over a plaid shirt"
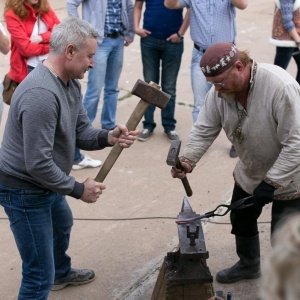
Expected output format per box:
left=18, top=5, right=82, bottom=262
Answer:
left=67, top=0, right=134, bottom=45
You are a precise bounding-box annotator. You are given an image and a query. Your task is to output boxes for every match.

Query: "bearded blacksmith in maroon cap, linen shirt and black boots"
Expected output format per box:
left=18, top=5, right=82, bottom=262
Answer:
left=172, top=43, right=300, bottom=283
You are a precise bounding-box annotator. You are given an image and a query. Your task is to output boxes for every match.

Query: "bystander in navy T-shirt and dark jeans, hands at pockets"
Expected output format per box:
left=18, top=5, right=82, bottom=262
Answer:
left=134, top=0, right=189, bottom=141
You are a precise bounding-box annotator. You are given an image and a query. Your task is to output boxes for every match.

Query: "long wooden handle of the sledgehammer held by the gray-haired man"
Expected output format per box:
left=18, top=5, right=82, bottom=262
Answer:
left=95, top=99, right=149, bottom=182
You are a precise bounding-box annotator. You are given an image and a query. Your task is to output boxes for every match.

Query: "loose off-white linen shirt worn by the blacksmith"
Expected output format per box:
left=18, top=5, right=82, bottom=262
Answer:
left=184, top=64, right=300, bottom=199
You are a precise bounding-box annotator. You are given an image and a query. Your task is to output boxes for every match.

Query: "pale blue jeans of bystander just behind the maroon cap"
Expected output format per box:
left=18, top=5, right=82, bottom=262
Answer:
left=191, top=49, right=212, bottom=123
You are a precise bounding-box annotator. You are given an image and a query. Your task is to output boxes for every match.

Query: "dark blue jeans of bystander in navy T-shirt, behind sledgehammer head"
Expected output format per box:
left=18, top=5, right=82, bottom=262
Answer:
left=141, top=35, right=183, bottom=131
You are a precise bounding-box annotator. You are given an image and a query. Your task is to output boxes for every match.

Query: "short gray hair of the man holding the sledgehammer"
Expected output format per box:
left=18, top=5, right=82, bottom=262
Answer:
left=50, top=17, right=98, bottom=54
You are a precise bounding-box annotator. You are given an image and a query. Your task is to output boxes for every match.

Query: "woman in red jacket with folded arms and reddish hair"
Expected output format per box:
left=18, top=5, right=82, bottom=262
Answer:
left=4, top=0, right=60, bottom=83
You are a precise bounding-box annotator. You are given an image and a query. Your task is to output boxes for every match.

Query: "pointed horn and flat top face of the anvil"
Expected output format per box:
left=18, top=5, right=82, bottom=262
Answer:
left=177, top=196, right=208, bottom=258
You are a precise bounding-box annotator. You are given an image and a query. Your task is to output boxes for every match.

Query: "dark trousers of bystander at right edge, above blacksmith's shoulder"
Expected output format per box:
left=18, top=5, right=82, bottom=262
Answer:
left=274, top=47, right=300, bottom=84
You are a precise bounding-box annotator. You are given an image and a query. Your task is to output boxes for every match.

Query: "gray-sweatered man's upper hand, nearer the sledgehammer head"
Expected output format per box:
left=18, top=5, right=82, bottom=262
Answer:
left=108, top=124, right=139, bottom=148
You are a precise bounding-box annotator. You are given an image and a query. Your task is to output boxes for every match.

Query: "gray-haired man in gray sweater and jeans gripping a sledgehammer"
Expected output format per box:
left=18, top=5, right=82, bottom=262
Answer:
left=0, top=18, right=138, bottom=299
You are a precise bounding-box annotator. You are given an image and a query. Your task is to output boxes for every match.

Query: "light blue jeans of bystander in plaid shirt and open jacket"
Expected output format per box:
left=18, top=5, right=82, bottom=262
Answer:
left=83, top=37, right=124, bottom=129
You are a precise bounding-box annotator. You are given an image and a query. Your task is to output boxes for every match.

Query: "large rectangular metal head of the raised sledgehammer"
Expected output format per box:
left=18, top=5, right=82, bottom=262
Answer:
left=131, top=79, right=171, bottom=108
